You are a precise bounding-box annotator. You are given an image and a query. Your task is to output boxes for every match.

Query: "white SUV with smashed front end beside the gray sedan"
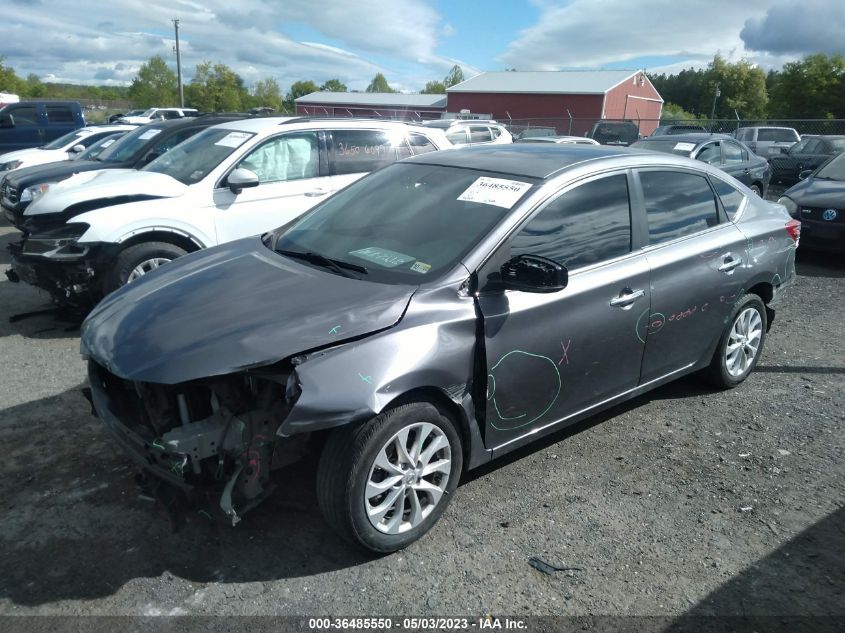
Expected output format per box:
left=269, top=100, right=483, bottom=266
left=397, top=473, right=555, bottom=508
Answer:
left=12, top=117, right=451, bottom=304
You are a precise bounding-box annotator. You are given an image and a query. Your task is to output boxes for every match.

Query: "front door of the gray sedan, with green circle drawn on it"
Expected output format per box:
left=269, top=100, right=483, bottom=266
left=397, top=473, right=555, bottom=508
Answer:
left=478, top=172, right=650, bottom=448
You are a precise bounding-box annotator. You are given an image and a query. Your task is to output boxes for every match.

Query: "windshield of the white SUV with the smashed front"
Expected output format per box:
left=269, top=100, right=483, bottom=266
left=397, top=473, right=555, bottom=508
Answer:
left=141, top=128, right=255, bottom=185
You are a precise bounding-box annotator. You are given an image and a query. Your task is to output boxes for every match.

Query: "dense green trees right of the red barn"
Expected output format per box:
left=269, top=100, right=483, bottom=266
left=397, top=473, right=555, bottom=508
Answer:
left=649, top=54, right=845, bottom=119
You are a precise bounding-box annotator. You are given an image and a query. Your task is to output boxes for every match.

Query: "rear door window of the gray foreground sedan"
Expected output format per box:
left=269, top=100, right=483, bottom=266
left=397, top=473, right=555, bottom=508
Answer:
left=640, top=171, right=719, bottom=244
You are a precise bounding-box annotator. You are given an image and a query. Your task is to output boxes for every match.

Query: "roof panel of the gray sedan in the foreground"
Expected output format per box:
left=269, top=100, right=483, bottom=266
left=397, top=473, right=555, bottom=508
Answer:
left=403, top=143, right=656, bottom=179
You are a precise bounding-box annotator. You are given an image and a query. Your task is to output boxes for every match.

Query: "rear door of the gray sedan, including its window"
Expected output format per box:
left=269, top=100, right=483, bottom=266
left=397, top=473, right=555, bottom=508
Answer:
left=636, top=167, right=748, bottom=383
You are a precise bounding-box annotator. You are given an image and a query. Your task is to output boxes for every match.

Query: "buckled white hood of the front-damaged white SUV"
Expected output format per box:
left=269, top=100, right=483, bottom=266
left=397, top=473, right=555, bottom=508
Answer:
left=24, top=169, right=188, bottom=215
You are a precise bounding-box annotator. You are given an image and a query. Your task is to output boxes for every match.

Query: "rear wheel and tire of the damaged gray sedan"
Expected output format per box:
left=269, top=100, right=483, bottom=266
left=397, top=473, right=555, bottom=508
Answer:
left=705, top=294, right=766, bottom=389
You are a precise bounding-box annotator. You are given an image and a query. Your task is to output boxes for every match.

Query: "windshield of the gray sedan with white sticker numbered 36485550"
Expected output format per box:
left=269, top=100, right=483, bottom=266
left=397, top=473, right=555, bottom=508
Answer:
left=270, top=163, right=537, bottom=285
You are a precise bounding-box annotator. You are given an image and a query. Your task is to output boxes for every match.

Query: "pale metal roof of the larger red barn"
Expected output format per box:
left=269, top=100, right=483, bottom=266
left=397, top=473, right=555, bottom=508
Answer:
left=446, top=70, right=641, bottom=94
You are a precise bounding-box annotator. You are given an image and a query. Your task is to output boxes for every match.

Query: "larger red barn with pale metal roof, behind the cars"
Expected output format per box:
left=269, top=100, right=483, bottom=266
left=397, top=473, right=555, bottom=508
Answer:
left=446, top=70, right=663, bottom=136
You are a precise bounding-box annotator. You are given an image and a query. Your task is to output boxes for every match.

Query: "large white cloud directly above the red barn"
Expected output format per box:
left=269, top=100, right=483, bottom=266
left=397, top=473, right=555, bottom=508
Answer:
left=499, top=0, right=771, bottom=70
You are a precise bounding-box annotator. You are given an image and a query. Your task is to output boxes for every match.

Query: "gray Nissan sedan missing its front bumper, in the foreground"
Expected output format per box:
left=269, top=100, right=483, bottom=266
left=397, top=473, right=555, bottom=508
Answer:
left=82, top=144, right=800, bottom=552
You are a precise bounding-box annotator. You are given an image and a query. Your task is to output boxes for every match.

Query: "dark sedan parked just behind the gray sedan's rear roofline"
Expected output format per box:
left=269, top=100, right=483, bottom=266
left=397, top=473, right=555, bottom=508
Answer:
left=632, top=134, right=770, bottom=197
